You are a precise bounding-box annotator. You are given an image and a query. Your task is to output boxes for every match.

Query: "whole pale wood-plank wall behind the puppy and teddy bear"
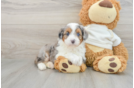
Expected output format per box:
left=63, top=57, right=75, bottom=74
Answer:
left=1, top=0, right=133, bottom=61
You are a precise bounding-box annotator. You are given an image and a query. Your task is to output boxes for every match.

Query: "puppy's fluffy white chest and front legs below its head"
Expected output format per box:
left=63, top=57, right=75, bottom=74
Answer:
left=56, top=40, right=86, bottom=66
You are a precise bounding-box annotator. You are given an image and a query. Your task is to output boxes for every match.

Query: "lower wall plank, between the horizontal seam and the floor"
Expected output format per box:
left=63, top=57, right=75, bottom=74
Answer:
left=1, top=25, right=133, bottom=61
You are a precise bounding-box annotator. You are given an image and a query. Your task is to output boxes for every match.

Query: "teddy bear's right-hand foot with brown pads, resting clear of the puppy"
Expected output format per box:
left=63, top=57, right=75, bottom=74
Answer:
left=93, top=55, right=127, bottom=73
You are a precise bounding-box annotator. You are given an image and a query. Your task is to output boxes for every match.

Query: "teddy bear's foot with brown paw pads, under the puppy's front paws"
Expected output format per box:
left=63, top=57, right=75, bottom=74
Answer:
left=54, top=56, right=86, bottom=73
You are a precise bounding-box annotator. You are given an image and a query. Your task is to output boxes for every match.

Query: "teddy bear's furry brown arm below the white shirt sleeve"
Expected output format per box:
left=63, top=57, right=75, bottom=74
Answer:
left=113, top=42, right=128, bottom=60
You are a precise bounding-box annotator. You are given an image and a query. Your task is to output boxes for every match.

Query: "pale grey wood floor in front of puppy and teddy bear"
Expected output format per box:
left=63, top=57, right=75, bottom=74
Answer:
left=1, top=59, right=133, bottom=88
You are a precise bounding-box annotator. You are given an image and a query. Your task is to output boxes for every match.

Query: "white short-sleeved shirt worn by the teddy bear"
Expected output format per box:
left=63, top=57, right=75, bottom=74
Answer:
left=85, top=24, right=121, bottom=50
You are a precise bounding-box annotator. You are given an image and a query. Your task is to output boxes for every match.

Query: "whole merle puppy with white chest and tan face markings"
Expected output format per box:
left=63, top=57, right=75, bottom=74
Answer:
left=35, top=23, right=88, bottom=70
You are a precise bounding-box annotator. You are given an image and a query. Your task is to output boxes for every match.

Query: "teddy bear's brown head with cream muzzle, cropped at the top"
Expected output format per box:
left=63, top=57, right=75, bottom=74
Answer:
left=79, top=0, right=121, bottom=29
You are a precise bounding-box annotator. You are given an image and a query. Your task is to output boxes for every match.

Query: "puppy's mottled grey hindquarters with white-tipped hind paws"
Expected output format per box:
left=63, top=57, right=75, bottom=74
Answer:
left=35, top=43, right=57, bottom=70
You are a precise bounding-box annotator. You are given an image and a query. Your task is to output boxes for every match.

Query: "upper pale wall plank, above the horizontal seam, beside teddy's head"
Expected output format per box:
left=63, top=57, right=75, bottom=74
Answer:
left=1, top=0, right=133, bottom=24
